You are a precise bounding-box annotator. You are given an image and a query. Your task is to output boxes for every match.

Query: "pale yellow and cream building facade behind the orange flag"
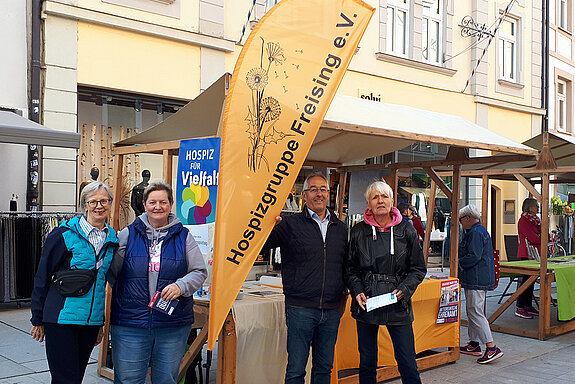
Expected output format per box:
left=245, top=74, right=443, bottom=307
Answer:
left=30, top=0, right=544, bottom=252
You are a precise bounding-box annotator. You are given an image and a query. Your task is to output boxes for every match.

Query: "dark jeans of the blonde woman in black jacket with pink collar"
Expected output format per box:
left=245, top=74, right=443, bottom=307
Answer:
left=357, top=321, right=421, bottom=384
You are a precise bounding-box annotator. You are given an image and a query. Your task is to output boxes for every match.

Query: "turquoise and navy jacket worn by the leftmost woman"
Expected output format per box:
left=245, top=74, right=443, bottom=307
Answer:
left=30, top=216, right=118, bottom=325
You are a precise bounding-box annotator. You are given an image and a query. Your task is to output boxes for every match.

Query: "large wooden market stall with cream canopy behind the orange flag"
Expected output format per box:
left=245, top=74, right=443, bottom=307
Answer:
left=99, top=75, right=537, bottom=383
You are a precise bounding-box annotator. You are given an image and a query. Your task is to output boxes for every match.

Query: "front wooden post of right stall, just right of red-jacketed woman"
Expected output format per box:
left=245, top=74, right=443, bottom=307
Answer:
left=538, top=172, right=551, bottom=340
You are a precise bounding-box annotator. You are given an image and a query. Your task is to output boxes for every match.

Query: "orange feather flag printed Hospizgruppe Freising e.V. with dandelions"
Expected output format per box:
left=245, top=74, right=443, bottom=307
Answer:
left=208, top=0, right=374, bottom=350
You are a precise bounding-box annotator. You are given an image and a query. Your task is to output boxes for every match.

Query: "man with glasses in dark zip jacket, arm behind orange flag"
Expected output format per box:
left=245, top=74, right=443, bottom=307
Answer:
left=264, top=173, right=347, bottom=384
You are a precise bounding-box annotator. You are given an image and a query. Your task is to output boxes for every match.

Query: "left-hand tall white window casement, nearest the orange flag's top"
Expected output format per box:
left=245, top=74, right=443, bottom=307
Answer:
left=386, top=0, right=409, bottom=56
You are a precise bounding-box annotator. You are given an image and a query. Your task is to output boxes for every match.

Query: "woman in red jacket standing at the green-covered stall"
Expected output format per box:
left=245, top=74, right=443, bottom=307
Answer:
left=515, top=198, right=541, bottom=319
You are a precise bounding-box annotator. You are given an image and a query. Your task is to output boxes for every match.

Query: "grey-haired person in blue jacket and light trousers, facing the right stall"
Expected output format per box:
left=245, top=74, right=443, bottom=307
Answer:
left=459, top=205, right=503, bottom=364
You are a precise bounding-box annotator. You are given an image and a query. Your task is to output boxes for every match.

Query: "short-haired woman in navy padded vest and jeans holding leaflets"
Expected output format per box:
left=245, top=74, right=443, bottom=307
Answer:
left=109, top=181, right=207, bottom=384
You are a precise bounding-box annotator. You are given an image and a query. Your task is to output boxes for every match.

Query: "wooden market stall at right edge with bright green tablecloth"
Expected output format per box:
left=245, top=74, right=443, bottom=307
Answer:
left=432, top=133, right=575, bottom=340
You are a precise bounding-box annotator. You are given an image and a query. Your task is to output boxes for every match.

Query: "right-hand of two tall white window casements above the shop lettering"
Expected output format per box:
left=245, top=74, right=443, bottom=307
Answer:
left=421, top=0, right=443, bottom=64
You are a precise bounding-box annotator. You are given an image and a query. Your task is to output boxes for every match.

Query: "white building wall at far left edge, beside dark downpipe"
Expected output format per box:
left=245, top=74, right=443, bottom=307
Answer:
left=0, top=0, right=28, bottom=211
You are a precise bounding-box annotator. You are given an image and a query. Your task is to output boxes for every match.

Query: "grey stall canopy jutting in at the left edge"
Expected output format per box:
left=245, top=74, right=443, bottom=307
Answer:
left=0, top=111, right=80, bottom=149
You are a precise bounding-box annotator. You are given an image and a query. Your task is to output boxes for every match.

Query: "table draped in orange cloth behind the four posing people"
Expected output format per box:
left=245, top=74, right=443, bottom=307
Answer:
left=180, top=280, right=459, bottom=384
